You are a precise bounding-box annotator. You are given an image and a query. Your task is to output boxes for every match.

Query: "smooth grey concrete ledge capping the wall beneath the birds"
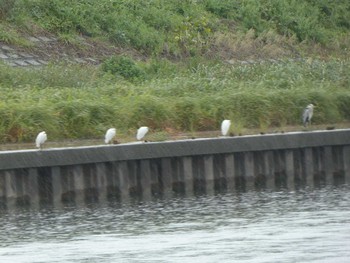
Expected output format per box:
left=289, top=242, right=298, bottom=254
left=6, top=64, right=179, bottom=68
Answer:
left=0, top=129, right=350, bottom=170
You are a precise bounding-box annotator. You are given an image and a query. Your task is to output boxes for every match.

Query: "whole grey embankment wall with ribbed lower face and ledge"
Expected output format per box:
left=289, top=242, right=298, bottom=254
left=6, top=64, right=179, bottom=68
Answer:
left=0, top=130, right=350, bottom=206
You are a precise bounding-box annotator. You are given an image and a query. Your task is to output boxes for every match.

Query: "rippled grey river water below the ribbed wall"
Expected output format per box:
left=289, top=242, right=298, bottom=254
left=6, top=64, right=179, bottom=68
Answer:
left=0, top=185, right=350, bottom=263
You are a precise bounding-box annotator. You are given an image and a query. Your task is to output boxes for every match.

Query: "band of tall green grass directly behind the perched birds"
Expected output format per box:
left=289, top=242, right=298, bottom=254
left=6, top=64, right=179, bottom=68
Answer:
left=0, top=60, right=350, bottom=142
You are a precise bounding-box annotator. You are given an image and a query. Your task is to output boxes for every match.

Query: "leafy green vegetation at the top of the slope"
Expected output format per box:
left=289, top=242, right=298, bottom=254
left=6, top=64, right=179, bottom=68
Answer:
left=0, top=0, right=350, bottom=58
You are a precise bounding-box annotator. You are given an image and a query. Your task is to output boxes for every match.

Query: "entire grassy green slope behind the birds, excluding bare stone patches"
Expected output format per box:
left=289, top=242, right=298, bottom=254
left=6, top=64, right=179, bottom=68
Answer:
left=0, top=0, right=350, bottom=142
